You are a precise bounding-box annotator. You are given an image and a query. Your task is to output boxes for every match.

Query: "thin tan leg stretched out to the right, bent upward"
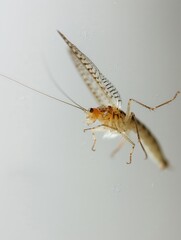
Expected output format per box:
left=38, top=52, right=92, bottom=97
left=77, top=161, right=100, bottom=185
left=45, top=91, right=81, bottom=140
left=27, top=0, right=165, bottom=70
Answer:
left=126, top=91, right=180, bottom=118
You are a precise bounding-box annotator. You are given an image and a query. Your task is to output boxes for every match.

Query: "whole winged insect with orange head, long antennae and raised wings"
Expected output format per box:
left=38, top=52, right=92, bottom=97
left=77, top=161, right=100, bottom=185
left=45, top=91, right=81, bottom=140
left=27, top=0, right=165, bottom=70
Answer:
left=1, top=31, right=180, bottom=169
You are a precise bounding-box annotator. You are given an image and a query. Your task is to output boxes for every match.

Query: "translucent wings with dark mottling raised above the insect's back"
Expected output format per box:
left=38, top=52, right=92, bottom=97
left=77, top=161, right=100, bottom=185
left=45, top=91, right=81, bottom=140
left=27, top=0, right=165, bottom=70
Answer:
left=58, top=31, right=121, bottom=107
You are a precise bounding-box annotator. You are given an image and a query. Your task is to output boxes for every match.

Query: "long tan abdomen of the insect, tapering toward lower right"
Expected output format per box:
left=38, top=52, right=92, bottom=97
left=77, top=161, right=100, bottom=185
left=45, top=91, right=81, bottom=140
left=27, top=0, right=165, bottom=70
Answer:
left=131, top=120, right=169, bottom=169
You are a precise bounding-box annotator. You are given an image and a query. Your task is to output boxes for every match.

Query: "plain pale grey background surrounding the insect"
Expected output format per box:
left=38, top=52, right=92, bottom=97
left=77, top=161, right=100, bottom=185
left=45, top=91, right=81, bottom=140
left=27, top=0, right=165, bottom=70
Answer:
left=0, top=0, right=181, bottom=240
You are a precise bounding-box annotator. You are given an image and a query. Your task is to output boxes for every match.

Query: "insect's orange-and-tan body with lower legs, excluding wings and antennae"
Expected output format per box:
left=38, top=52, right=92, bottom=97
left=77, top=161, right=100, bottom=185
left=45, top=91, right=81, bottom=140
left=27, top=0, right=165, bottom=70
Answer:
left=86, top=106, right=168, bottom=168
